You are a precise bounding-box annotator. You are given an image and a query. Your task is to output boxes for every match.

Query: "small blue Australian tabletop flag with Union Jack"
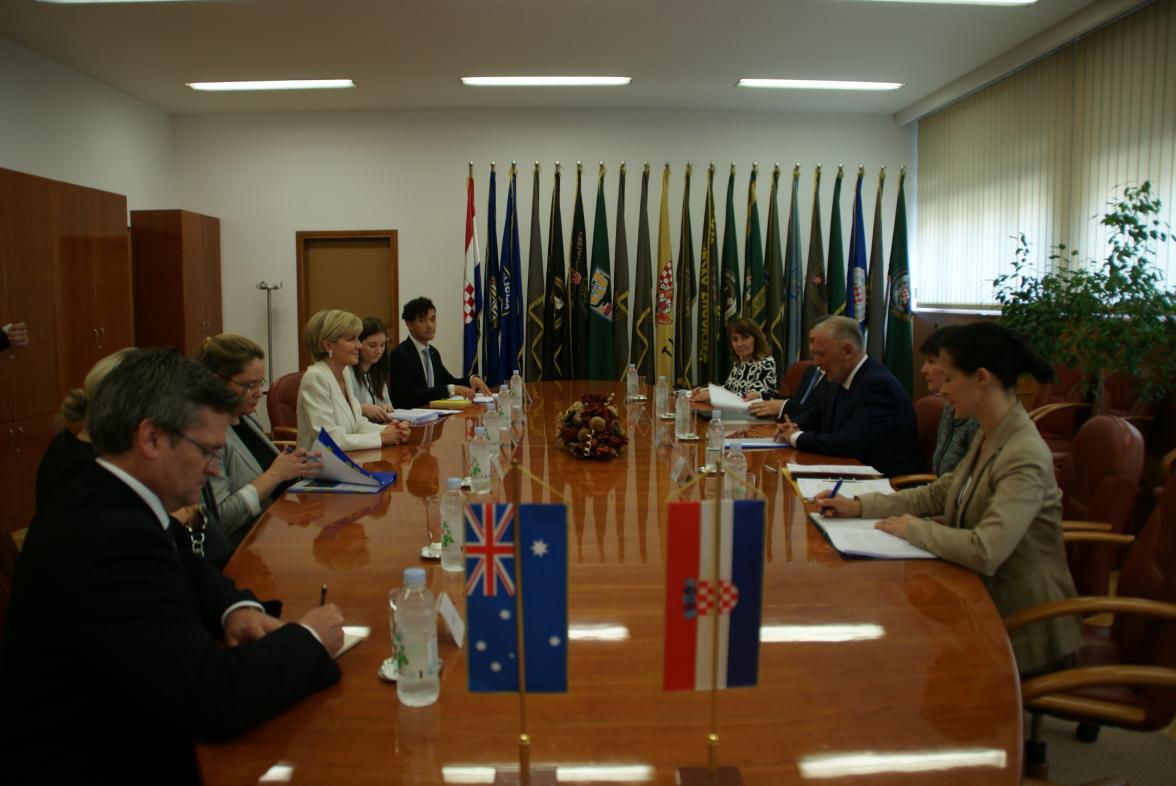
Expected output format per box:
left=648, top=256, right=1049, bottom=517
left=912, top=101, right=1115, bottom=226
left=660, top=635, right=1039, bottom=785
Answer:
left=466, top=504, right=568, bottom=693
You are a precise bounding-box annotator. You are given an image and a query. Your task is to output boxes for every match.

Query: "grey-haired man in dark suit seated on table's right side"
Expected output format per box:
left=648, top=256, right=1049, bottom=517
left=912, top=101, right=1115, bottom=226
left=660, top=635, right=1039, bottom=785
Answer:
left=777, top=317, right=923, bottom=477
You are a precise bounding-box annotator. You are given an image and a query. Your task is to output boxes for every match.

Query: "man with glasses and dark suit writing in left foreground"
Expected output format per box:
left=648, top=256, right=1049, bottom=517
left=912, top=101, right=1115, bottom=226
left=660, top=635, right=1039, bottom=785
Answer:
left=0, top=349, right=342, bottom=784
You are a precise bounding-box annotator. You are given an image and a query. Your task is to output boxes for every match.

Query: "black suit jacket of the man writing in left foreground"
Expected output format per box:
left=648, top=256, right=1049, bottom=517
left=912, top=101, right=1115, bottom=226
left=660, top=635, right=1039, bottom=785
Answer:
left=0, top=464, right=339, bottom=785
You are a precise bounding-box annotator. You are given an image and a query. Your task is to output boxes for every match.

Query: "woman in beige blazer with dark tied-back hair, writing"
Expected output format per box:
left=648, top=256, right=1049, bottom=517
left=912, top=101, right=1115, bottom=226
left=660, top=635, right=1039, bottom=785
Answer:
left=817, top=322, right=1082, bottom=674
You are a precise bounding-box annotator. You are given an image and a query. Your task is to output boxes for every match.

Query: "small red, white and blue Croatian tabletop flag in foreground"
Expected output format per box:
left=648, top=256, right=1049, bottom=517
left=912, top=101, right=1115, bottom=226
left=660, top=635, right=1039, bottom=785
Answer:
left=663, top=500, right=764, bottom=691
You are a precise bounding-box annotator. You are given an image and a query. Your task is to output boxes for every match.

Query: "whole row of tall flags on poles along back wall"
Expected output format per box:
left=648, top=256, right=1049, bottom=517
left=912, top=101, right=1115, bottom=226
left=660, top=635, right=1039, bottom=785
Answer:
left=462, top=164, right=914, bottom=392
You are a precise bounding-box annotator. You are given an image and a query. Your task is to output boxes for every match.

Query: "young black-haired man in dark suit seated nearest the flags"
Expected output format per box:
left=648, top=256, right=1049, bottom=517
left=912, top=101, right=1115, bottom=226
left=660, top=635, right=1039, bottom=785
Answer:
left=388, top=298, right=490, bottom=408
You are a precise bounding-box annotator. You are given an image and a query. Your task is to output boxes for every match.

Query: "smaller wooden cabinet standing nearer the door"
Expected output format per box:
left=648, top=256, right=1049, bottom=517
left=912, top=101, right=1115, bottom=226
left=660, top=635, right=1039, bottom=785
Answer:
left=131, top=211, right=221, bottom=355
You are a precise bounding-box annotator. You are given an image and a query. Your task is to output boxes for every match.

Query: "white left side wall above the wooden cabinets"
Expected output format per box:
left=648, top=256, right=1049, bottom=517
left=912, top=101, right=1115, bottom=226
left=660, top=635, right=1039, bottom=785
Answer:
left=0, top=36, right=176, bottom=209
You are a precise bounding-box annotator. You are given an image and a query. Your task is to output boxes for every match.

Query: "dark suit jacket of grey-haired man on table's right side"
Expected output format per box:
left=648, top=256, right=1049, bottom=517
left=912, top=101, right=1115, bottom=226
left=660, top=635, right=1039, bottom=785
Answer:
left=795, top=359, right=924, bottom=478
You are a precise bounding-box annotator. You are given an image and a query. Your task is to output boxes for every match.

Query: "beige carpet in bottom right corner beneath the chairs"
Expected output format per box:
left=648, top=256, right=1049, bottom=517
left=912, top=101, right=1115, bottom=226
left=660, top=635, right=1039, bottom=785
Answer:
left=1025, top=717, right=1176, bottom=786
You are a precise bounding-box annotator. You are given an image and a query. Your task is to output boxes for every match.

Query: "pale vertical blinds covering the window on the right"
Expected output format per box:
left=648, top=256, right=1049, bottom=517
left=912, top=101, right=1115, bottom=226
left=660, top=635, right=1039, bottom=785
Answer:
left=911, top=0, right=1176, bottom=306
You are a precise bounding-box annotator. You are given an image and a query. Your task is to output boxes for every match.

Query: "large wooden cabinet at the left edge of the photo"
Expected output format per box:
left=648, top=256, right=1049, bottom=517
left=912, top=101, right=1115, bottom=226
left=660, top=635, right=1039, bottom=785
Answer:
left=0, top=164, right=134, bottom=532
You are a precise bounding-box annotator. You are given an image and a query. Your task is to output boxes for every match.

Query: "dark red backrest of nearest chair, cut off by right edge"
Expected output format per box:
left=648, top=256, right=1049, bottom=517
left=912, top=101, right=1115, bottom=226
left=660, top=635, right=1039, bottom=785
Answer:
left=1111, top=470, right=1176, bottom=728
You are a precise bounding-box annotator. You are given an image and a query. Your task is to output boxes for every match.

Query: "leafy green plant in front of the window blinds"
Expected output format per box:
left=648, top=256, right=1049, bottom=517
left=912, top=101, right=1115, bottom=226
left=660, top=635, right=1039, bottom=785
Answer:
left=993, top=181, right=1176, bottom=405
